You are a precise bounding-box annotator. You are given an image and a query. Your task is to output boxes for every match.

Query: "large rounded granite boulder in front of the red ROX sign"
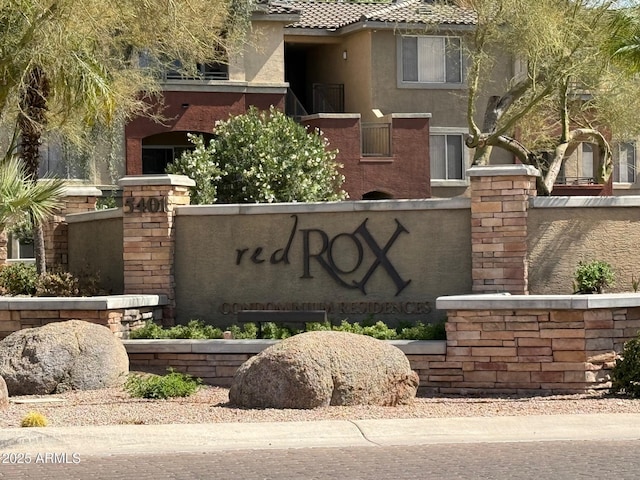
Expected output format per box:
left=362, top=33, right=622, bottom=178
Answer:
left=229, top=331, right=418, bottom=408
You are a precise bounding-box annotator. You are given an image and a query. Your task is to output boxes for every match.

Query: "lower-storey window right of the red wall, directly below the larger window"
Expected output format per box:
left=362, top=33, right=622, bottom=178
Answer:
left=429, top=134, right=465, bottom=180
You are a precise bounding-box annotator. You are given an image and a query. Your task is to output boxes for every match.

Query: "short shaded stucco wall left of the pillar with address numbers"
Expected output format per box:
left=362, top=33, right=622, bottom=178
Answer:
left=69, top=214, right=124, bottom=294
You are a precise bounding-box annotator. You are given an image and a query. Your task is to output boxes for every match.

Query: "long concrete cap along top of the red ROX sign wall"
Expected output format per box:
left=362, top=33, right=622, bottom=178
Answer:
left=175, top=197, right=471, bottom=216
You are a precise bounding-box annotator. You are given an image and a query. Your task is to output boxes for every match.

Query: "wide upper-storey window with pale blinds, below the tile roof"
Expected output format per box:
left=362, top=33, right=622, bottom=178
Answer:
left=401, top=36, right=462, bottom=84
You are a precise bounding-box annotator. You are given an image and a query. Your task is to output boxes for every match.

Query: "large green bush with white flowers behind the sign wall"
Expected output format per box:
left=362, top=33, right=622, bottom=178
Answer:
left=167, top=107, right=346, bottom=204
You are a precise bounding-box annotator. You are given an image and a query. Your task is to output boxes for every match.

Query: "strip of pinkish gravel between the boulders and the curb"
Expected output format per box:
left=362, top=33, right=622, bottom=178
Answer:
left=5, top=386, right=640, bottom=428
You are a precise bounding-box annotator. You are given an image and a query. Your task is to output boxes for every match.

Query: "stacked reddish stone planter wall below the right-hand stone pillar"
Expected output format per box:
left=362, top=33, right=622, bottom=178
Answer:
left=436, top=307, right=640, bottom=393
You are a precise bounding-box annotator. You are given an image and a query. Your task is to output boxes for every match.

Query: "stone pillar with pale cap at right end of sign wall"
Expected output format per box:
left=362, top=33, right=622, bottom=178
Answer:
left=467, top=165, right=539, bottom=295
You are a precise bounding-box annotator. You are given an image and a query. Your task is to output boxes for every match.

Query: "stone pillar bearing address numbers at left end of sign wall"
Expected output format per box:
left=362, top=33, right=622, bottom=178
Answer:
left=118, top=175, right=195, bottom=325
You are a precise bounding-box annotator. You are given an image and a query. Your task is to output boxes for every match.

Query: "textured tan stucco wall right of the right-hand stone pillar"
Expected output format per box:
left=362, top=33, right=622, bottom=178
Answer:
left=528, top=205, right=640, bottom=294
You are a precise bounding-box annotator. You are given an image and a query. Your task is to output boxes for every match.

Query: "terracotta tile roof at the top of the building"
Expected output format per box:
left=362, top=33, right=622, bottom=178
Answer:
left=279, top=0, right=476, bottom=30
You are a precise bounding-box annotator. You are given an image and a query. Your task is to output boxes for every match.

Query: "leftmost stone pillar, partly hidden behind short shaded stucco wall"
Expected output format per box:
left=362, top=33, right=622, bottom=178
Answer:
left=43, top=185, right=102, bottom=271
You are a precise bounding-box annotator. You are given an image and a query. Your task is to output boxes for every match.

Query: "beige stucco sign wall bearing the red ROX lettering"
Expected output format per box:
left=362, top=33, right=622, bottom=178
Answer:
left=175, top=201, right=471, bottom=325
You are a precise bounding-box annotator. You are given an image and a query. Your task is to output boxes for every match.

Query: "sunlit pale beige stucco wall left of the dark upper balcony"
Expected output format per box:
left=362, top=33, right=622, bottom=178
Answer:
left=229, top=21, right=284, bottom=84
